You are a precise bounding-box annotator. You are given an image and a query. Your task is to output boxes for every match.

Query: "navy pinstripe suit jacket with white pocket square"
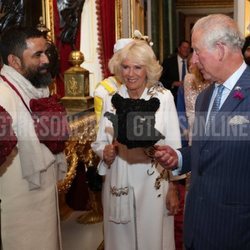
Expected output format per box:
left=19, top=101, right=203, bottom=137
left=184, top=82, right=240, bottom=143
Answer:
left=180, top=67, right=250, bottom=250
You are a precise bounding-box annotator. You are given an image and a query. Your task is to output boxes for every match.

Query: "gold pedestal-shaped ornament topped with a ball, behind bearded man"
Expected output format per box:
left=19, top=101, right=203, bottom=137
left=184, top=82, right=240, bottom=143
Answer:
left=62, top=50, right=94, bottom=112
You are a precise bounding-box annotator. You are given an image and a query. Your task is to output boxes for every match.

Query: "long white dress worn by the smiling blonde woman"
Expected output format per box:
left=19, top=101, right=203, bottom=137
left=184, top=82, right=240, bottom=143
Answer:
left=92, top=85, right=181, bottom=250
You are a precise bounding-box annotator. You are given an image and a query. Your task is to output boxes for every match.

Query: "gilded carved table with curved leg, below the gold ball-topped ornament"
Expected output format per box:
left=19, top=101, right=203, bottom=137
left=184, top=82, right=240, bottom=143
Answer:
left=58, top=112, right=103, bottom=224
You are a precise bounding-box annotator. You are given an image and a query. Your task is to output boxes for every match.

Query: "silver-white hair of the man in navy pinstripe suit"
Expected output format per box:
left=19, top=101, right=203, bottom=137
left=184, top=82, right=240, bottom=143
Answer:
left=192, top=14, right=245, bottom=50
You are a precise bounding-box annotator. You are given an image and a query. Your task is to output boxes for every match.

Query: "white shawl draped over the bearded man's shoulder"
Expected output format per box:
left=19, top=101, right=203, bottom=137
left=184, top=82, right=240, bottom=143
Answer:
left=0, top=65, right=67, bottom=190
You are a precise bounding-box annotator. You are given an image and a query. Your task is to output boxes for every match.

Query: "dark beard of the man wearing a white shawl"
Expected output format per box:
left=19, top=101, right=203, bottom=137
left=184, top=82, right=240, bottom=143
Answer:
left=25, top=65, right=52, bottom=88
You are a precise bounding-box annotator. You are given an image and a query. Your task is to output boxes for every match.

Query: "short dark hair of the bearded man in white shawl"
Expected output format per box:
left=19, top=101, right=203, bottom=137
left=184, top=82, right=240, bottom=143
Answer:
left=0, top=27, right=44, bottom=64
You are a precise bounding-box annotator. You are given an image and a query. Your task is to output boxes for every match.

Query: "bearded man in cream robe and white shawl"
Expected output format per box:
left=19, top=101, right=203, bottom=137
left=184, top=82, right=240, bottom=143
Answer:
left=0, top=27, right=66, bottom=250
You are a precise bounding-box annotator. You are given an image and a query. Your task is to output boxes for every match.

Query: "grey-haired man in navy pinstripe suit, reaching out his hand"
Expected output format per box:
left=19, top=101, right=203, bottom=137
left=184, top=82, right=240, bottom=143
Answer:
left=155, top=14, right=250, bottom=250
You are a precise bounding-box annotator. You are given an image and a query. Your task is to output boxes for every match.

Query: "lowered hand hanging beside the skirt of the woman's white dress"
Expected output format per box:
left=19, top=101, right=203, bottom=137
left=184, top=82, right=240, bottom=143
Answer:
left=166, top=182, right=180, bottom=215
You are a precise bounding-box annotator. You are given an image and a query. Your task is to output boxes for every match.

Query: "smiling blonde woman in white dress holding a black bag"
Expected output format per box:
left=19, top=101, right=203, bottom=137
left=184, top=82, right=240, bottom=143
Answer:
left=92, top=39, right=181, bottom=250
